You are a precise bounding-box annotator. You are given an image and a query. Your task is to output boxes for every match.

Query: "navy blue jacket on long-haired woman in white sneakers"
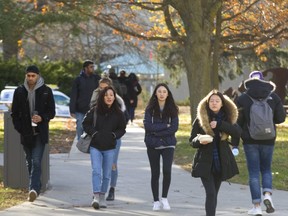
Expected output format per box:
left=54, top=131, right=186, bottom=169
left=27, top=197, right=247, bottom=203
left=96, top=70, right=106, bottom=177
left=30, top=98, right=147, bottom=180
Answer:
left=143, top=110, right=179, bottom=148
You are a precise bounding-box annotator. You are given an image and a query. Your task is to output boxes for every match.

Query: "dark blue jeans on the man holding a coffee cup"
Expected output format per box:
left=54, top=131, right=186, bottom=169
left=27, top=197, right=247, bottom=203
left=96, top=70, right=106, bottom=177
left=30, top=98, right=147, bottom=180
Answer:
left=23, top=135, right=45, bottom=194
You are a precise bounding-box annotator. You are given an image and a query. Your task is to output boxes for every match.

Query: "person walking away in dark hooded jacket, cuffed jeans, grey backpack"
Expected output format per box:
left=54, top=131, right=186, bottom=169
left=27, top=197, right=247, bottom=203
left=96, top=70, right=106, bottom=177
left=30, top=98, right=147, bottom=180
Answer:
left=236, top=71, right=286, bottom=215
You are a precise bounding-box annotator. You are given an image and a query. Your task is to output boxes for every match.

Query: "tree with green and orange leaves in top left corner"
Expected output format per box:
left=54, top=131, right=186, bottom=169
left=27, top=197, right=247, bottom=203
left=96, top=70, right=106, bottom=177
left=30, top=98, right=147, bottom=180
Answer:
left=0, top=0, right=87, bottom=60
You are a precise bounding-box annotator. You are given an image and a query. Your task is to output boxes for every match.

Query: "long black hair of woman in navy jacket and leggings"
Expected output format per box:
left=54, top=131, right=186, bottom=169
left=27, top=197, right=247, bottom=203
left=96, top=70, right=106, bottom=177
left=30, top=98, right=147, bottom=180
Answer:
left=146, top=83, right=179, bottom=118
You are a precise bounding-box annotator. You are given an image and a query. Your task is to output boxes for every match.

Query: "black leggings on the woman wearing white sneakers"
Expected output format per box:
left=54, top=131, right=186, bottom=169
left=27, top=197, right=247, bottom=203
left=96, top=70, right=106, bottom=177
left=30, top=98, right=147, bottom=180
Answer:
left=147, top=148, right=174, bottom=201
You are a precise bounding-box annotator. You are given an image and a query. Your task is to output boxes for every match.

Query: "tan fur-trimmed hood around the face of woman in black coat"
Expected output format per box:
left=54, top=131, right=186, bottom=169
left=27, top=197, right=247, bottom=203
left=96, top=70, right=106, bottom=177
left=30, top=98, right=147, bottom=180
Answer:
left=197, top=95, right=238, bottom=137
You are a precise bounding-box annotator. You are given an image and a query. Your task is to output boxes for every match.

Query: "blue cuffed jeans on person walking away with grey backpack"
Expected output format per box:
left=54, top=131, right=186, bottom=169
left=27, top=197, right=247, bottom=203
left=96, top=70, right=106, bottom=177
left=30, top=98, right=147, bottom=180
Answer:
left=243, top=144, right=274, bottom=204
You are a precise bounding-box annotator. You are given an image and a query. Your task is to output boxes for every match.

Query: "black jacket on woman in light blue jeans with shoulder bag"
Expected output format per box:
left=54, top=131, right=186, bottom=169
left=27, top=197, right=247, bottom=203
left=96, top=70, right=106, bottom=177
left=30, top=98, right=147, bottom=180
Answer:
left=82, top=108, right=126, bottom=151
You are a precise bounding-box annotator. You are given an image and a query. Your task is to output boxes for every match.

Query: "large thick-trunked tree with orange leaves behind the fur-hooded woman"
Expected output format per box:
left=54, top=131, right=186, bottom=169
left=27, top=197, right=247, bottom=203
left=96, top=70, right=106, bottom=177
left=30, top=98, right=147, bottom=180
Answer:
left=2, top=0, right=288, bottom=118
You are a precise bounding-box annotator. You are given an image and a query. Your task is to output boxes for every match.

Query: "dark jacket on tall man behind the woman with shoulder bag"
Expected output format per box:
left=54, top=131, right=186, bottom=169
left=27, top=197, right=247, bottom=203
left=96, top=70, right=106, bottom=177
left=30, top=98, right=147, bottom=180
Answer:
left=69, top=71, right=100, bottom=114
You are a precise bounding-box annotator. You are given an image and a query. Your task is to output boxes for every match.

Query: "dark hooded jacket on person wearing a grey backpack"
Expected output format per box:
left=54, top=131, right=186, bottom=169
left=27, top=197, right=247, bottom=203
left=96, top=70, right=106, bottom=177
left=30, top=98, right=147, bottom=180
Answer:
left=236, top=78, right=286, bottom=145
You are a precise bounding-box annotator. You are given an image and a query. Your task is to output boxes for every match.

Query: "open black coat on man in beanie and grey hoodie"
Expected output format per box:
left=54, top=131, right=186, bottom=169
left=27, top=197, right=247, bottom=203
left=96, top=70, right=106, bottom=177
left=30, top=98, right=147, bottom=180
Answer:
left=11, top=85, right=55, bottom=145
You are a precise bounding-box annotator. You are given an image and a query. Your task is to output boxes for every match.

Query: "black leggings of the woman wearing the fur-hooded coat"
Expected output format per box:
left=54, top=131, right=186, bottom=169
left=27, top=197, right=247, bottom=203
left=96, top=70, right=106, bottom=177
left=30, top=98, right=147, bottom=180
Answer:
left=201, top=173, right=222, bottom=216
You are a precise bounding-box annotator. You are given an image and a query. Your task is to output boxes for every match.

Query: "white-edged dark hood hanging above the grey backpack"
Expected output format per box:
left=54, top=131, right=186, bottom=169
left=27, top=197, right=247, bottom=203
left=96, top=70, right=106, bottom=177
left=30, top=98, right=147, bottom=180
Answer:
left=244, top=78, right=276, bottom=99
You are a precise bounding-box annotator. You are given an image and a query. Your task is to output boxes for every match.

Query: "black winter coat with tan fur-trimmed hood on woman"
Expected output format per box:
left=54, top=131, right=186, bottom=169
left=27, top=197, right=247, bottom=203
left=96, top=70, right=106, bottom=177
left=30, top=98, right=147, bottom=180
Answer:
left=189, top=95, right=241, bottom=180
